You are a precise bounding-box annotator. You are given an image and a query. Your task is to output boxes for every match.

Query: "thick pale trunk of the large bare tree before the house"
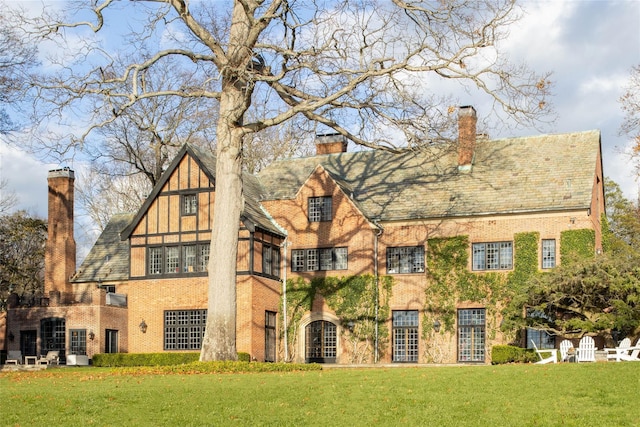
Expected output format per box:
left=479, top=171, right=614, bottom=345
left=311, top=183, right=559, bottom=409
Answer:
left=200, top=3, right=252, bottom=361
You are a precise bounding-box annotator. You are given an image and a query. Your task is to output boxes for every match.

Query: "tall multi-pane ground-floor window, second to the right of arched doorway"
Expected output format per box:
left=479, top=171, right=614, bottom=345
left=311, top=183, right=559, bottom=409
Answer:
left=458, top=308, right=486, bottom=362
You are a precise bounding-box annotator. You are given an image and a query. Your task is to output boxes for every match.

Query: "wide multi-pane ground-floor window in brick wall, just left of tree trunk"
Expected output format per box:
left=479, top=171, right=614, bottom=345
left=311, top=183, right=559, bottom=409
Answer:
left=164, top=310, right=207, bottom=350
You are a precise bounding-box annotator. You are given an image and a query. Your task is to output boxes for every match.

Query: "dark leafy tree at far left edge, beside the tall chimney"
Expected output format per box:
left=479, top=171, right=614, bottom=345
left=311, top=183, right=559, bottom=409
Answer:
left=0, top=211, right=47, bottom=309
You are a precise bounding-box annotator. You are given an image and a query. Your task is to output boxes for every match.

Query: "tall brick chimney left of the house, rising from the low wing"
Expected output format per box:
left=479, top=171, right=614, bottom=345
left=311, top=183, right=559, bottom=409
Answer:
left=44, top=168, right=76, bottom=292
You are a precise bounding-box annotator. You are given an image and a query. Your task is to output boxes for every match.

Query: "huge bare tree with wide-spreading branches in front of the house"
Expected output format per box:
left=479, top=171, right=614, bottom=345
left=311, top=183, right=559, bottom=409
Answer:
left=17, top=0, right=550, bottom=360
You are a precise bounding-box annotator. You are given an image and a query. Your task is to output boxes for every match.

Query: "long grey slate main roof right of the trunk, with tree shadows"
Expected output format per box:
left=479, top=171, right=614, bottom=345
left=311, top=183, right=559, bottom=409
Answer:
left=258, top=131, right=601, bottom=221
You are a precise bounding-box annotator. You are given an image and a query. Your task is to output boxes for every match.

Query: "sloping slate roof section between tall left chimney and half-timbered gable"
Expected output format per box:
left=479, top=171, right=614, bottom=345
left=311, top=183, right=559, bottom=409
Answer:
left=71, top=214, right=134, bottom=282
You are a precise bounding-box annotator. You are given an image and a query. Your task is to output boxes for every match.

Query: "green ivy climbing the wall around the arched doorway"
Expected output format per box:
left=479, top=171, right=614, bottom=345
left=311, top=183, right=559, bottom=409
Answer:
left=280, top=274, right=393, bottom=363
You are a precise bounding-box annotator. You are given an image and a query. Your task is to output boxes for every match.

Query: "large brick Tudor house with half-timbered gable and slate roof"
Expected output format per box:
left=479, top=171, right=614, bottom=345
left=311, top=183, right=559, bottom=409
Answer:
left=6, top=107, right=604, bottom=363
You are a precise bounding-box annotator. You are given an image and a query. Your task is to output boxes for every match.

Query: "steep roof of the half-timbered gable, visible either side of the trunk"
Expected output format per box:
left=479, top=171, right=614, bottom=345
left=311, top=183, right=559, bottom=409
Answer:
left=122, top=144, right=283, bottom=239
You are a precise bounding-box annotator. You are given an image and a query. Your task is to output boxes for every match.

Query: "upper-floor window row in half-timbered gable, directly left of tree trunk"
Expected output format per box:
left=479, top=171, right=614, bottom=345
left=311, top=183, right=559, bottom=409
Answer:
left=147, top=243, right=210, bottom=275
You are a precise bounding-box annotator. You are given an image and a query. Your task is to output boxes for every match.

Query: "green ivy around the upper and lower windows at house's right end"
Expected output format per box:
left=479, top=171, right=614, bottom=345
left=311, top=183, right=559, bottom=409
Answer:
left=422, top=229, right=595, bottom=346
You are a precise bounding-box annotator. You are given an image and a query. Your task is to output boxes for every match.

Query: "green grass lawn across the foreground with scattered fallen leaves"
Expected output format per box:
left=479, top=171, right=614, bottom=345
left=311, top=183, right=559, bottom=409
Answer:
left=0, top=363, right=640, bottom=427
